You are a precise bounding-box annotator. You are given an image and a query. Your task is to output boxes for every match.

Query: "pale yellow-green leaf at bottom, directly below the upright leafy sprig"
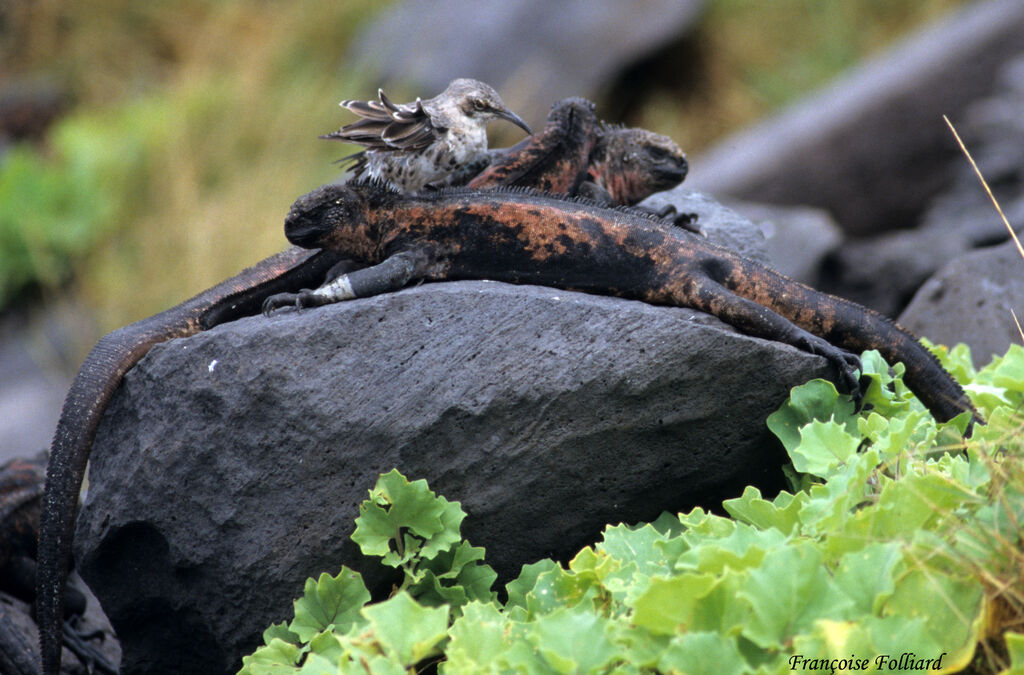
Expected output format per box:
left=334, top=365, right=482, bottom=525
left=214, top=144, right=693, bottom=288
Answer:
left=362, top=592, right=449, bottom=666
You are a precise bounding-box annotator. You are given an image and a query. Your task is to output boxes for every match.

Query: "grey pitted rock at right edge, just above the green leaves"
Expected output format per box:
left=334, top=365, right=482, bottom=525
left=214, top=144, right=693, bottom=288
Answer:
left=899, top=242, right=1024, bottom=367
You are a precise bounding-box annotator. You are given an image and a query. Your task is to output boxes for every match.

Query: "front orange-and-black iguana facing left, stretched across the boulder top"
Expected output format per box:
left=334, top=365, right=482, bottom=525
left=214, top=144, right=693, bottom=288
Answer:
left=264, top=184, right=977, bottom=428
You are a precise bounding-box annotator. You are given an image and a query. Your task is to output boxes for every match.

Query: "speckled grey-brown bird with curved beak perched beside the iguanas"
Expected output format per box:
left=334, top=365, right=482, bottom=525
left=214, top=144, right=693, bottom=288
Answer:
left=321, top=78, right=534, bottom=192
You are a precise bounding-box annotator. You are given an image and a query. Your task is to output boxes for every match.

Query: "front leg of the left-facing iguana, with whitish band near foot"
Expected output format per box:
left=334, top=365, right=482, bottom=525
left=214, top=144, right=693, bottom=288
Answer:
left=263, top=251, right=430, bottom=314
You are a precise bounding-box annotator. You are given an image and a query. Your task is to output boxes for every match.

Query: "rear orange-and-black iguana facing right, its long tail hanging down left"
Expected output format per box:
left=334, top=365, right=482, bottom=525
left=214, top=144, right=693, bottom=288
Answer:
left=37, top=98, right=686, bottom=674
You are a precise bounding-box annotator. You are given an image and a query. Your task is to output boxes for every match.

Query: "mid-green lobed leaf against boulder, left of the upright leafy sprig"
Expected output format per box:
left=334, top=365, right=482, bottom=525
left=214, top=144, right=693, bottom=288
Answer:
left=288, top=566, right=370, bottom=642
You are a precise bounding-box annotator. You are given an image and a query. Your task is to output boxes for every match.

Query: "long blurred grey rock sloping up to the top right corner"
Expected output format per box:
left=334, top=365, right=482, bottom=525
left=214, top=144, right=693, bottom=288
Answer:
left=687, top=0, right=1024, bottom=236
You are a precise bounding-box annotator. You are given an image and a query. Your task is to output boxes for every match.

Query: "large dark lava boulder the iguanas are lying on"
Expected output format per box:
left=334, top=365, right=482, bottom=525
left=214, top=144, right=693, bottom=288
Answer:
left=76, top=282, right=833, bottom=673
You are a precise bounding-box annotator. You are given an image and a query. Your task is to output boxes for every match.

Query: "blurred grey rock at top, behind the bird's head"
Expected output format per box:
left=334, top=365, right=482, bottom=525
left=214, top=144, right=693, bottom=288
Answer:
left=345, top=0, right=703, bottom=122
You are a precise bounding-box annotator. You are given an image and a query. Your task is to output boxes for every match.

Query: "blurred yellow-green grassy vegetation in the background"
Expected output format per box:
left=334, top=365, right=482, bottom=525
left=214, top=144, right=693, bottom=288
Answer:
left=0, top=0, right=964, bottom=358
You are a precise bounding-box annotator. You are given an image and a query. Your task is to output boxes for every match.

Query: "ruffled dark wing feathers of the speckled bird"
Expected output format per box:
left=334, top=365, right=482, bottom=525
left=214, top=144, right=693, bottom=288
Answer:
left=321, top=89, right=447, bottom=151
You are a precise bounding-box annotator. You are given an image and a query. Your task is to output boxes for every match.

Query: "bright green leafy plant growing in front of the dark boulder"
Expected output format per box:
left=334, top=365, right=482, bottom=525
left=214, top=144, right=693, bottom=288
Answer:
left=242, top=347, right=1024, bottom=675
